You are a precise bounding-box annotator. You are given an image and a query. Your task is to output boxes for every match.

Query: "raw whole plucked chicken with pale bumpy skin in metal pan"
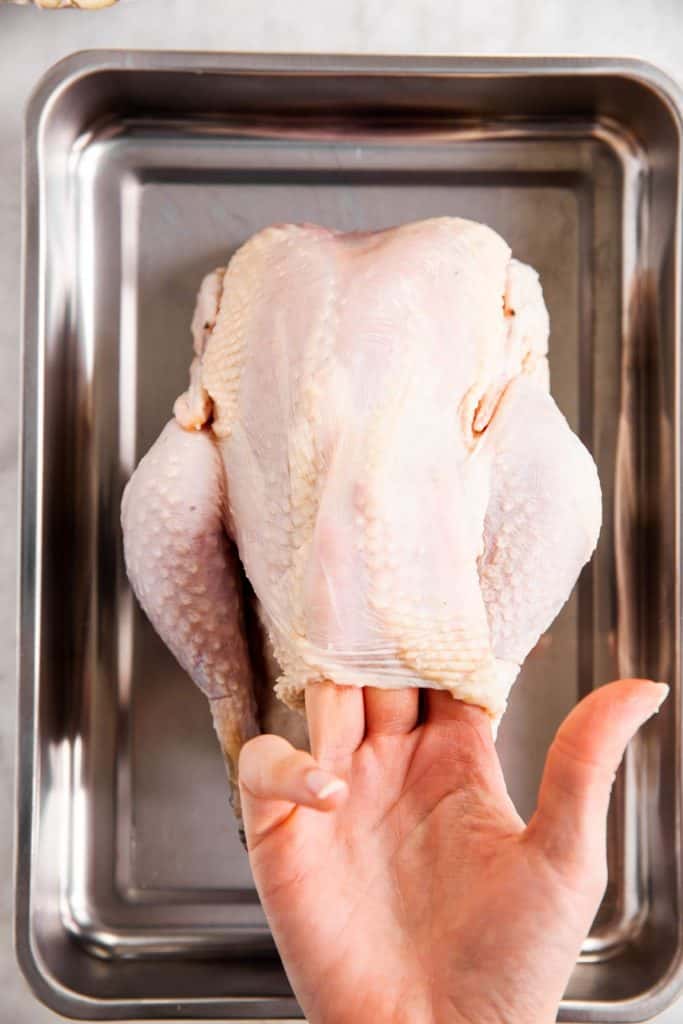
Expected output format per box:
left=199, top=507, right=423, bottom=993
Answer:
left=122, top=217, right=601, bottom=823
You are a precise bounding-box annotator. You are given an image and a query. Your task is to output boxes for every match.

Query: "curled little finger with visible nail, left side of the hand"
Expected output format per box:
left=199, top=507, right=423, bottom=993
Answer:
left=240, top=735, right=348, bottom=849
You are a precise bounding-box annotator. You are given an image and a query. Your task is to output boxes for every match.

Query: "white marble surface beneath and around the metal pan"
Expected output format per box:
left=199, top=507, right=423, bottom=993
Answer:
left=0, top=0, right=683, bottom=1024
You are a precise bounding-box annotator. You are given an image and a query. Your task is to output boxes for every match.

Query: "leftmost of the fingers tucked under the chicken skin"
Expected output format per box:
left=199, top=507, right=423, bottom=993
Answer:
left=306, top=681, right=366, bottom=762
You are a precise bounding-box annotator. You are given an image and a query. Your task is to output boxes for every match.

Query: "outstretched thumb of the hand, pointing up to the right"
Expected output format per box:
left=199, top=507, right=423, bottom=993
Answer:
left=527, top=679, right=669, bottom=866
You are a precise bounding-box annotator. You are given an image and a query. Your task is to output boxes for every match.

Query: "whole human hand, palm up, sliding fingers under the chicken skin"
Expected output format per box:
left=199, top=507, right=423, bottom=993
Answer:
left=240, top=679, right=667, bottom=1024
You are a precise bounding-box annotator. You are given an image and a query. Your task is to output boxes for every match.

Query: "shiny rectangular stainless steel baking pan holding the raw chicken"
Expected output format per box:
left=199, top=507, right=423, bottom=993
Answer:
left=16, top=51, right=682, bottom=1021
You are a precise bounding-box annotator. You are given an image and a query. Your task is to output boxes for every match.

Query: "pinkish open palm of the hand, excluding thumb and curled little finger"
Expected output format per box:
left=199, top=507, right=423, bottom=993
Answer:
left=241, top=679, right=667, bottom=1024
